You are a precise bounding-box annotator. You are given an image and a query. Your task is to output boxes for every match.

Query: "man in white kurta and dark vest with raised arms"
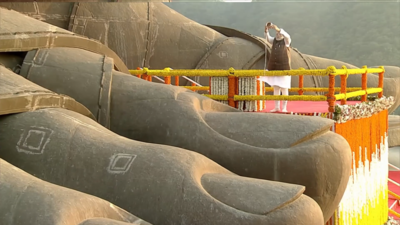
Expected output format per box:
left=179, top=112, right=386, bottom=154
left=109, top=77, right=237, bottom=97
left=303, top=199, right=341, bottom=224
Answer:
left=260, top=22, right=292, bottom=112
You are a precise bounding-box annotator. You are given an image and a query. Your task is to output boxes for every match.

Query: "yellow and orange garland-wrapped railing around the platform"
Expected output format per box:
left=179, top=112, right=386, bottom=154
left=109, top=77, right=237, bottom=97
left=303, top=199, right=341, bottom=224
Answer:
left=129, top=66, right=385, bottom=112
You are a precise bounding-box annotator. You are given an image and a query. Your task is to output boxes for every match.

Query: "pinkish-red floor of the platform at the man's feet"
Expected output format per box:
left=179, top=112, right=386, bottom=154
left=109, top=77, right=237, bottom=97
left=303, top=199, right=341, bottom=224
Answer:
left=262, top=101, right=360, bottom=114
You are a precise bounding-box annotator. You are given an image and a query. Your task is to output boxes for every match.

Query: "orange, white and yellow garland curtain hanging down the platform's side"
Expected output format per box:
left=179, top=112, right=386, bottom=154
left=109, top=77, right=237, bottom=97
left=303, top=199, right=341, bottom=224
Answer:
left=327, top=109, right=388, bottom=225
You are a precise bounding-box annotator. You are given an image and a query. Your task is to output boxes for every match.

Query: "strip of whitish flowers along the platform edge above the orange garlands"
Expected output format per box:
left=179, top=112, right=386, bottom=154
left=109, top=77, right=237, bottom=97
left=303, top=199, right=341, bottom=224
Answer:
left=333, top=96, right=394, bottom=123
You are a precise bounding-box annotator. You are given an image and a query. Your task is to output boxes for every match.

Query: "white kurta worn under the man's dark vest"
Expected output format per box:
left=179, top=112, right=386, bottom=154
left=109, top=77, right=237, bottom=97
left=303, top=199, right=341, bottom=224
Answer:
left=258, top=29, right=292, bottom=88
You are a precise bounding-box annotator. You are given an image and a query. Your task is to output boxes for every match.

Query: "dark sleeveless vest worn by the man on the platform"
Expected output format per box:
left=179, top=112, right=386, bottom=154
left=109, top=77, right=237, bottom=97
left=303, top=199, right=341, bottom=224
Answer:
left=268, top=38, right=290, bottom=70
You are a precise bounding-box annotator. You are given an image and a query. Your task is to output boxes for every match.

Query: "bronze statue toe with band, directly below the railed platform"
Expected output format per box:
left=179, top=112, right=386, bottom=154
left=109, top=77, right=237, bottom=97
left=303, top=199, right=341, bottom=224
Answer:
left=21, top=48, right=351, bottom=220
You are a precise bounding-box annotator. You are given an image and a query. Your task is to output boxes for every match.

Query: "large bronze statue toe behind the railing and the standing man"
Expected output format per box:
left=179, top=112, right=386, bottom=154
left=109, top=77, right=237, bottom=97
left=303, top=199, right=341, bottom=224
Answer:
left=0, top=2, right=400, bottom=113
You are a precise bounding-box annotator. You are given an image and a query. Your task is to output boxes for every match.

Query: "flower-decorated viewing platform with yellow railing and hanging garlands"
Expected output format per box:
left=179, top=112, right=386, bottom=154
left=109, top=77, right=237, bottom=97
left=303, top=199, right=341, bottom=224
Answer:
left=130, top=66, right=400, bottom=225
